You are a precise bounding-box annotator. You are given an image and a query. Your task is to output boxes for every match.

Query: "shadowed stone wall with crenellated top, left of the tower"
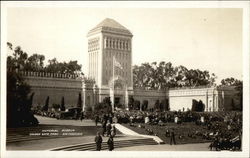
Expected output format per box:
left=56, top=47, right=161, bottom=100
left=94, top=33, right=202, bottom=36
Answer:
left=21, top=72, right=82, bottom=108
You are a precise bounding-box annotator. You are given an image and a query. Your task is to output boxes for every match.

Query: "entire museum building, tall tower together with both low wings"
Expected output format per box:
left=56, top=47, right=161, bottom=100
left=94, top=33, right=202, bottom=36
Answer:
left=21, top=18, right=239, bottom=111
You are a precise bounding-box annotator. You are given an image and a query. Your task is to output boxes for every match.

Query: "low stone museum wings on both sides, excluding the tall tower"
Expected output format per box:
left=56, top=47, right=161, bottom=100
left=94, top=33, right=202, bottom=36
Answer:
left=21, top=72, right=240, bottom=111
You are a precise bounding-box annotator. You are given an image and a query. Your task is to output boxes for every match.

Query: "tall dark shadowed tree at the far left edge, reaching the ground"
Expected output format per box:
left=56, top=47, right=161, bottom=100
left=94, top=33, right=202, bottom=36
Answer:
left=7, top=42, right=38, bottom=127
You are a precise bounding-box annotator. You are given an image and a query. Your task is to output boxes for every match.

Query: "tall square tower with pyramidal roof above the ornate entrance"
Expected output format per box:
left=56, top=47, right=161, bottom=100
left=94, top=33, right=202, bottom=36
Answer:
left=87, top=18, right=133, bottom=104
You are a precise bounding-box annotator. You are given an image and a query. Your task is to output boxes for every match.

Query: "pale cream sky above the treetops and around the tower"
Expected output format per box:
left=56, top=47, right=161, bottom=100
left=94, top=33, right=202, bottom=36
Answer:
left=7, top=7, right=243, bottom=83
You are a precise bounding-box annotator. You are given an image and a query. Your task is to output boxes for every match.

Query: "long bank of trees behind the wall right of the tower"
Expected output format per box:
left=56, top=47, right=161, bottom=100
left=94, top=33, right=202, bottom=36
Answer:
left=133, top=61, right=216, bottom=89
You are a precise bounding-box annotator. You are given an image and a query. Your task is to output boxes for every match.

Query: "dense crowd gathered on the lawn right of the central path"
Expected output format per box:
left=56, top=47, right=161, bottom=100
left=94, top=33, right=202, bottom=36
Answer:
left=114, top=110, right=242, bottom=150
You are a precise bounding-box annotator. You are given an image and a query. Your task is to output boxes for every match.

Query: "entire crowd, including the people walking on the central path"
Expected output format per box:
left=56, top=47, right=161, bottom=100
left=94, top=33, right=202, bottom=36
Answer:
left=33, top=105, right=242, bottom=150
